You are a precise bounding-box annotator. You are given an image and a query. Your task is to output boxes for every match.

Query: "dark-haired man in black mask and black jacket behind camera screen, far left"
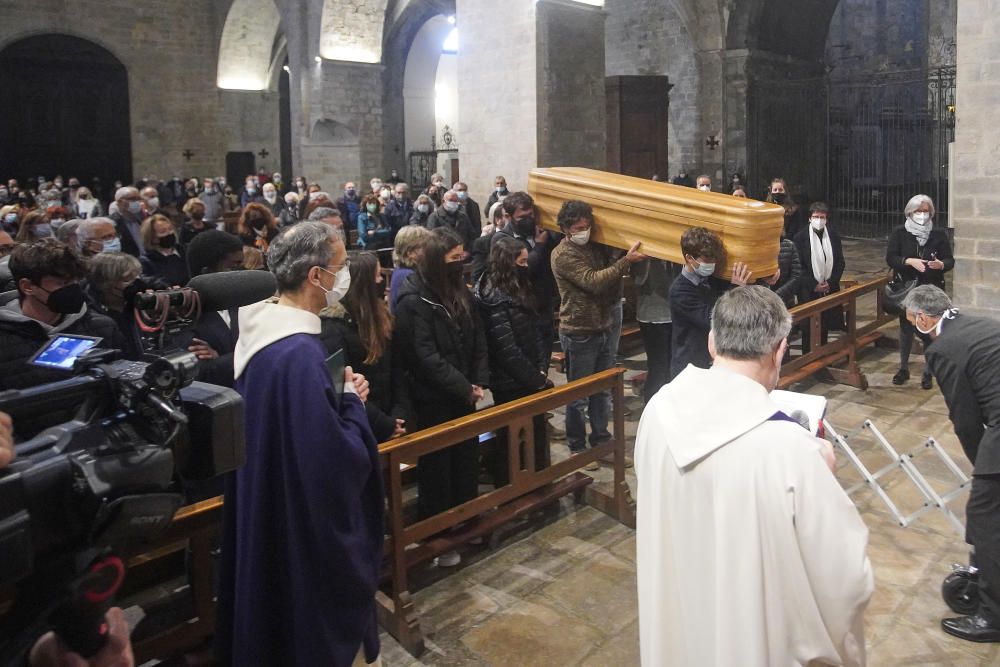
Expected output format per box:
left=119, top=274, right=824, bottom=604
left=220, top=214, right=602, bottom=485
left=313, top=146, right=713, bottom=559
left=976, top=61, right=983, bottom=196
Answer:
left=0, top=238, right=124, bottom=390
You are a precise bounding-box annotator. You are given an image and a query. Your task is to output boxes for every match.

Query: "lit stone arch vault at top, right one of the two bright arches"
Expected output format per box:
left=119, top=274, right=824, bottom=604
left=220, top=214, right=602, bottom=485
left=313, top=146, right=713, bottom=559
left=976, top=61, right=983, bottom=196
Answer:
left=319, top=0, right=387, bottom=63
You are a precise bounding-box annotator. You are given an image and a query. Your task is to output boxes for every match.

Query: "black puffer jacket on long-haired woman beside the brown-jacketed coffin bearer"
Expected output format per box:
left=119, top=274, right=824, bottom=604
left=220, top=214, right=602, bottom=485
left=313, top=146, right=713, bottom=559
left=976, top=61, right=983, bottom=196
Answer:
left=476, top=274, right=548, bottom=393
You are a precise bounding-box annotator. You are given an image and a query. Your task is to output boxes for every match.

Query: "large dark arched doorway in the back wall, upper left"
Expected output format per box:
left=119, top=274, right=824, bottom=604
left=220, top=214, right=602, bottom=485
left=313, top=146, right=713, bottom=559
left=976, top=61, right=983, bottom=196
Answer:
left=0, top=35, right=132, bottom=190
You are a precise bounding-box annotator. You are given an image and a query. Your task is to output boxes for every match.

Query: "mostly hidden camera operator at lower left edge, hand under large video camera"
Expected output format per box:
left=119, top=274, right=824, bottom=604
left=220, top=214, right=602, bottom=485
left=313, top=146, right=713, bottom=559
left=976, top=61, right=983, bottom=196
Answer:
left=0, top=412, right=135, bottom=667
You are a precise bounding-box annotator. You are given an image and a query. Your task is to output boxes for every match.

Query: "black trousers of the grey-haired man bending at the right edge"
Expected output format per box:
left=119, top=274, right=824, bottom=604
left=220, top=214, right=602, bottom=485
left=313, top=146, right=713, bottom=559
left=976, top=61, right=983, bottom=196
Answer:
left=965, top=475, right=1000, bottom=627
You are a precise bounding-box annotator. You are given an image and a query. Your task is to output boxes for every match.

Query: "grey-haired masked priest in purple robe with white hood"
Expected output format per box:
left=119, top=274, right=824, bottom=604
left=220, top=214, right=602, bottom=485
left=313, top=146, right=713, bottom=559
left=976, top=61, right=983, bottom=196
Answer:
left=217, top=221, right=384, bottom=666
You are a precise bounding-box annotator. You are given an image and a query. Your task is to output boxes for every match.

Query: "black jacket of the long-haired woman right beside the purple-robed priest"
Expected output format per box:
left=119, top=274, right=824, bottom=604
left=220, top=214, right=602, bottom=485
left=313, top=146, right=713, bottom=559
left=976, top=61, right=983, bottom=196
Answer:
left=319, top=303, right=410, bottom=442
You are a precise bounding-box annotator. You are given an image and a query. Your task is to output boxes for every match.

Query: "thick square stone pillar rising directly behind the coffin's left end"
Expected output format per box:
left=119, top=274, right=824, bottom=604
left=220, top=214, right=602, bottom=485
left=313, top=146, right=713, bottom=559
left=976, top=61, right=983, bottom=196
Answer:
left=456, top=0, right=607, bottom=201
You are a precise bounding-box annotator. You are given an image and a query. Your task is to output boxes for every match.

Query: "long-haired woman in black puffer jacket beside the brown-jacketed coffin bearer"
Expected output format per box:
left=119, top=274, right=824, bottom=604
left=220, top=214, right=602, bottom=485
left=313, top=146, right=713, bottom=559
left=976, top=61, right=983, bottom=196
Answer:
left=476, top=237, right=552, bottom=487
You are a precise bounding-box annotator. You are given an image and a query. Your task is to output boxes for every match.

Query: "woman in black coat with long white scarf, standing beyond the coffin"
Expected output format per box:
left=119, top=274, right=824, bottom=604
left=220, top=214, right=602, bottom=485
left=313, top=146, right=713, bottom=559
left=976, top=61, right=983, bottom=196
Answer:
left=794, top=202, right=845, bottom=354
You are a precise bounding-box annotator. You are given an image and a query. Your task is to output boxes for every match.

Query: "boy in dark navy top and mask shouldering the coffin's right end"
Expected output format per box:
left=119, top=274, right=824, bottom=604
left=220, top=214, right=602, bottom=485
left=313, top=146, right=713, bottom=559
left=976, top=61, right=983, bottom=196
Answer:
left=670, top=227, right=752, bottom=379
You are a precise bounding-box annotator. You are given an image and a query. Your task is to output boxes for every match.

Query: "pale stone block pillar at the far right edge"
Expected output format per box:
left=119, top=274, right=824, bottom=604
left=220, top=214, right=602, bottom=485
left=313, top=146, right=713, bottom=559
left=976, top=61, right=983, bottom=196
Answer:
left=951, top=0, right=1000, bottom=319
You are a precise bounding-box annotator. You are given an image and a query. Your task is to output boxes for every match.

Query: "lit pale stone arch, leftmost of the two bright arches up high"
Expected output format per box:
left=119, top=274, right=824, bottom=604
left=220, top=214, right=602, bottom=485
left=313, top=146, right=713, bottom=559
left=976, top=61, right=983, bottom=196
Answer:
left=216, top=0, right=281, bottom=90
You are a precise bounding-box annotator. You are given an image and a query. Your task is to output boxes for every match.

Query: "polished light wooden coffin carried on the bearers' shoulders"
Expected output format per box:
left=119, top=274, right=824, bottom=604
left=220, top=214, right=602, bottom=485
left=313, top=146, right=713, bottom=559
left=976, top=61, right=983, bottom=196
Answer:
left=528, top=167, right=784, bottom=279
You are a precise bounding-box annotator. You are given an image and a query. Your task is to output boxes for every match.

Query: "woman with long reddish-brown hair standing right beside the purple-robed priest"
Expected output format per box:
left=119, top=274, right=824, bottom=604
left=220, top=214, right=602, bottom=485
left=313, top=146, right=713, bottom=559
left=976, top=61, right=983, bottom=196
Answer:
left=319, top=252, right=408, bottom=442
